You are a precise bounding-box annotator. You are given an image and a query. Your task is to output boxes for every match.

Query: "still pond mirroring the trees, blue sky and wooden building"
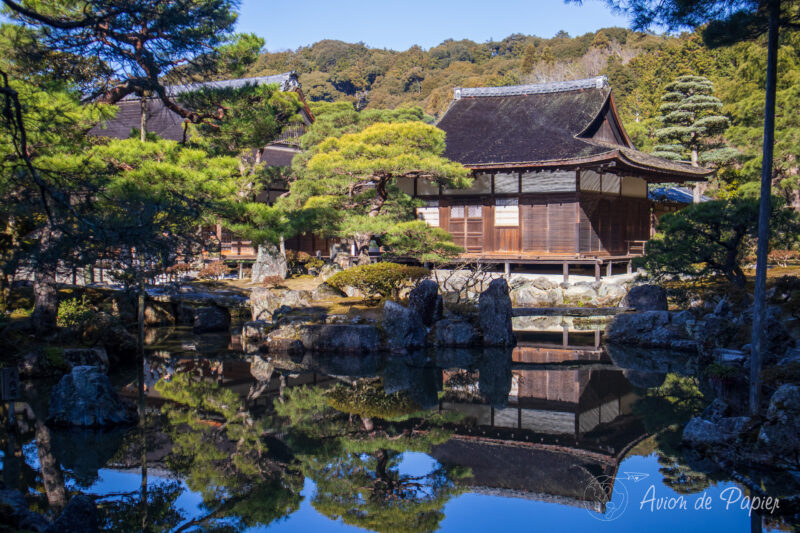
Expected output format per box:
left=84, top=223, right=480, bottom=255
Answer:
left=2, top=319, right=794, bottom=532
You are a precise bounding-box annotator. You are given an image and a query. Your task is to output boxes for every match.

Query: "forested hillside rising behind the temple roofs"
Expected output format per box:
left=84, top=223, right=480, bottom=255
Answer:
left=247, top=28, right=800, bottom=206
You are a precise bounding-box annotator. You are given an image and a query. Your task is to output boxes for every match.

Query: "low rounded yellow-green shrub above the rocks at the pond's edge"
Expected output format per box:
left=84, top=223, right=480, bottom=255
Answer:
left=327, top=263, right=430, bottom=298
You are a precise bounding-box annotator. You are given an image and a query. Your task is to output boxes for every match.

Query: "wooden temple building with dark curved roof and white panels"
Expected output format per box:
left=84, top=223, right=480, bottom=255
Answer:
left=401, top=76, right=711, bottom=276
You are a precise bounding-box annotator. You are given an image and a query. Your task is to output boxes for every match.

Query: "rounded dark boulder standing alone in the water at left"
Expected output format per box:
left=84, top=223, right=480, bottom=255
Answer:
left=47, top=366, right=134, bottom=427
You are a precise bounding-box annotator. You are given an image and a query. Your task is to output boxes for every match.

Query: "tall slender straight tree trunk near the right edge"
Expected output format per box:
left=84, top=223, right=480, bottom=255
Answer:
left=750, top=1, right=780, bottom=415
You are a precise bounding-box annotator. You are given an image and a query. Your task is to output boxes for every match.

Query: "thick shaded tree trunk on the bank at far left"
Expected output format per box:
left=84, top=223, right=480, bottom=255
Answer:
left=31, top=224, right=58, bottom=335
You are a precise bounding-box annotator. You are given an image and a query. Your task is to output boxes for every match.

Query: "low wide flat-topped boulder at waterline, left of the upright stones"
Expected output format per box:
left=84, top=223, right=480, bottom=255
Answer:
left=298, top=324, right=380, bottom=353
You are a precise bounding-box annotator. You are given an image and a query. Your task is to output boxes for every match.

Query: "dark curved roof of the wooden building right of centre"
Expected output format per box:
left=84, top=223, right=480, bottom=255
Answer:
left=437, top=77, right=709, bottom=179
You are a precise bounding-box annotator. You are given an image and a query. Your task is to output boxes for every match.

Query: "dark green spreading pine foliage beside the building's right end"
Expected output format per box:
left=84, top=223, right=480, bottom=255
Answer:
left=642, top=198, right=800, bottom=287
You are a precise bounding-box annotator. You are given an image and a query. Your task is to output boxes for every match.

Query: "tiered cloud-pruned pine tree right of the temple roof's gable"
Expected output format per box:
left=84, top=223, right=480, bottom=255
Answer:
left=653, top=75, right=738, bottom=167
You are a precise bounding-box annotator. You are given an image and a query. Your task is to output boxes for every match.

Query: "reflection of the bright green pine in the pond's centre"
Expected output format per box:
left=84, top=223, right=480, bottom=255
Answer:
left=276, top=379, right=469, bottom=531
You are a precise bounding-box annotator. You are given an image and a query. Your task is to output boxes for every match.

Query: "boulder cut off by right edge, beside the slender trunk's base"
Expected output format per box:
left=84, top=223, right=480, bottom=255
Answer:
left=758, top=384, right=800, bottom=461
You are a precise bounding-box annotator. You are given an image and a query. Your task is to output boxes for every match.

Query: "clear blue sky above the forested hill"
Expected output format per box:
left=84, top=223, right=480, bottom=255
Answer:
left=238, top=0, right=628, bottom=51
